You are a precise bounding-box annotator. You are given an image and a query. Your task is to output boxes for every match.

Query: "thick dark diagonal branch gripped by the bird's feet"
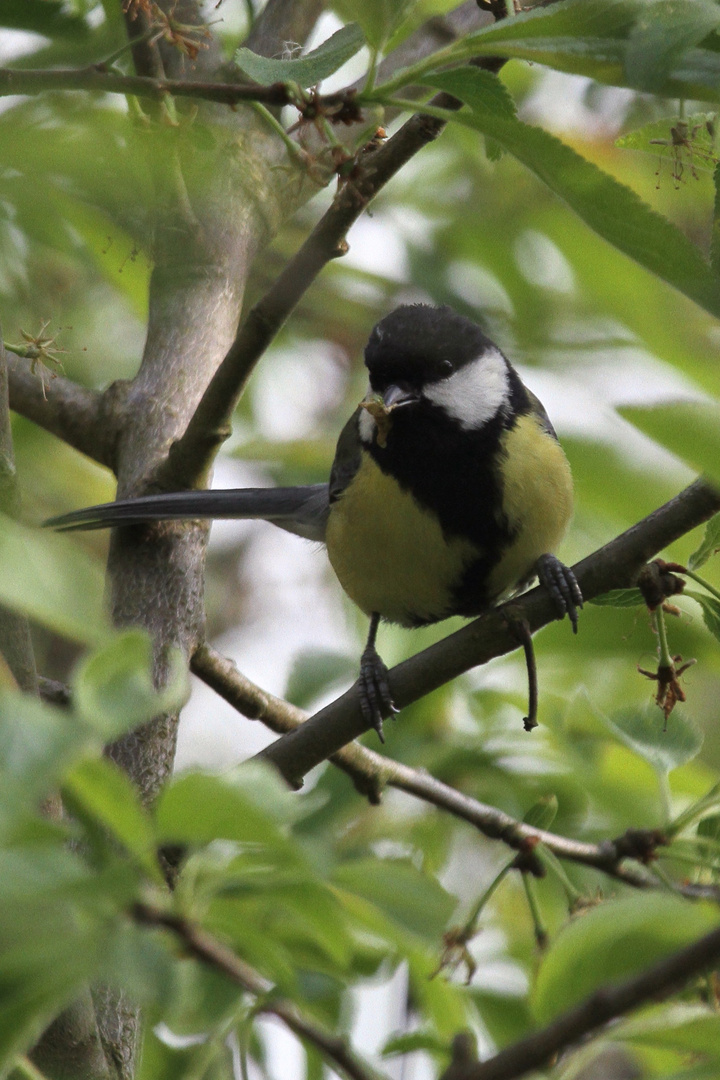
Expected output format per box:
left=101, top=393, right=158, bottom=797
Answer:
left=259, top=480, right=720, bottom=785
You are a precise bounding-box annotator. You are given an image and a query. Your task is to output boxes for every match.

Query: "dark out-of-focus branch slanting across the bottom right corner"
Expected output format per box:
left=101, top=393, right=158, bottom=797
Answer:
left=441, top=929, right=720, bottom=1080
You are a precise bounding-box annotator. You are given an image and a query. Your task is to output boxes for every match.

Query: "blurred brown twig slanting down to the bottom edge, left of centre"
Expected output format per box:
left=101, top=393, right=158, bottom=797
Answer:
left=132, top=903, right=383, bottom=1080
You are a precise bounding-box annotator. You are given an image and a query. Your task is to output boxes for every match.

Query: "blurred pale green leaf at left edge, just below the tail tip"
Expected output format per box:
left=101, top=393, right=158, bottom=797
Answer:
left=0, top=514, right=111, bottom=645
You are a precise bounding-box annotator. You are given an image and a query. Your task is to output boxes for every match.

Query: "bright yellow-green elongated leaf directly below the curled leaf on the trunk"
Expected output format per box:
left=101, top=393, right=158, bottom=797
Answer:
left=63, top=758, right=163, bottom=883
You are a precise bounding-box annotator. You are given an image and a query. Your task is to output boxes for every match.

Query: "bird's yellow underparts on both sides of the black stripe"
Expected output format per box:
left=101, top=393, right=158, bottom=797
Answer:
left=326, top=416, right=572, bottom=625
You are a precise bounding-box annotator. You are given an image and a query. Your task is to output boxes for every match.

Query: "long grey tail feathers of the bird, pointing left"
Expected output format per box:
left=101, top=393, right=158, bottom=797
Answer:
left=44, top=484, right=329, bottom=540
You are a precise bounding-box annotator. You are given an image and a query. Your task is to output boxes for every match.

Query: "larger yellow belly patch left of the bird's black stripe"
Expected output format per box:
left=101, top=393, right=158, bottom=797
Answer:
left=326, top=451, right=478, bottom=625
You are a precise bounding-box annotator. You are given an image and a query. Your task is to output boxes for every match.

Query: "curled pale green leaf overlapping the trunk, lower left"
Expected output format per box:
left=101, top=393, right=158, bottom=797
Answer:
left=72, top=630, right=188, bottom=739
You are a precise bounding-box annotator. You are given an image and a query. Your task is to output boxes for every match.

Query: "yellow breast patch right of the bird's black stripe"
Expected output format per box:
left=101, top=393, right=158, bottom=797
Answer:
left=488, top=416, right=572, bottom=597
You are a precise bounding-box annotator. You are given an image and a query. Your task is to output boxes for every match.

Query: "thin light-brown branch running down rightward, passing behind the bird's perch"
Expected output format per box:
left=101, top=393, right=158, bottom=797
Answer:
left=190, top=644, right=720, bottom=901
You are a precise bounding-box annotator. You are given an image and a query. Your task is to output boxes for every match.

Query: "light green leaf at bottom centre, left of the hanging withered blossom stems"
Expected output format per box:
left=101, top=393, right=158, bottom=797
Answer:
left=332, top=858, right=457, bottom=942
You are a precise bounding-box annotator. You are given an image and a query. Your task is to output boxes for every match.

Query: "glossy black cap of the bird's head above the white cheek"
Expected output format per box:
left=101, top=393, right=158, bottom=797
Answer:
left=365, top=303, right=498, bottom=393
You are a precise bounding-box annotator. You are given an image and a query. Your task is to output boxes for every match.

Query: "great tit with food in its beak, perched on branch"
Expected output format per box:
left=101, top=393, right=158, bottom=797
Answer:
left=46, top=305, right=582, bottom=738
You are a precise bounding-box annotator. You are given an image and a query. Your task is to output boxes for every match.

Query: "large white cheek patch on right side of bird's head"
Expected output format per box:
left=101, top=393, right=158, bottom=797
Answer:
left=423, top=349, right=508, bottom=431
